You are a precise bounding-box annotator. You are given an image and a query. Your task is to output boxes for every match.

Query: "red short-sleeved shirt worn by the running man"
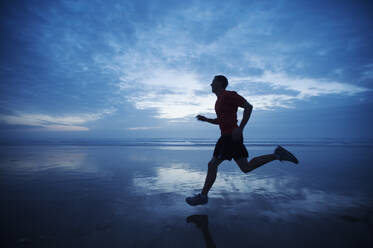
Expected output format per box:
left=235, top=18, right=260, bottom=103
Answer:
left=215, top=90, right=246, bottom=135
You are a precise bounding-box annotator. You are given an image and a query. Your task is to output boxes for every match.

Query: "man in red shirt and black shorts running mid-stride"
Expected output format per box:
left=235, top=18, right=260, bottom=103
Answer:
left=185, top=75, right=298, bottom=206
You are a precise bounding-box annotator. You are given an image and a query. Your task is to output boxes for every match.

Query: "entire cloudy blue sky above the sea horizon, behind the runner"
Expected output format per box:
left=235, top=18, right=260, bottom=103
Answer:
left=0, top=0, right=373, bottom=140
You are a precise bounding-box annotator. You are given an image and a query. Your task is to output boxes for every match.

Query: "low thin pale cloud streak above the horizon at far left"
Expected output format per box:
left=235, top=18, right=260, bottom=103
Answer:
left=0, top=109, right=116, bottom=131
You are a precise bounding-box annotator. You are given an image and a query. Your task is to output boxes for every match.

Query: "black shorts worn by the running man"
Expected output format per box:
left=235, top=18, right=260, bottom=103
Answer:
left=214, top=135, right=249, bottom=161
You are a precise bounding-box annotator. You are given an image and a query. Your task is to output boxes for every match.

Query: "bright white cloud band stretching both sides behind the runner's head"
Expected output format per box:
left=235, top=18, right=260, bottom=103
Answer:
left=114, top=49, right=368, bottom=116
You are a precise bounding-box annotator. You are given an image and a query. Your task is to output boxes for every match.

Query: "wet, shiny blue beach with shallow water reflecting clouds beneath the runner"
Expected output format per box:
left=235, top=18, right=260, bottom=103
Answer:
left=0, top=144, right=373, bottom=247
